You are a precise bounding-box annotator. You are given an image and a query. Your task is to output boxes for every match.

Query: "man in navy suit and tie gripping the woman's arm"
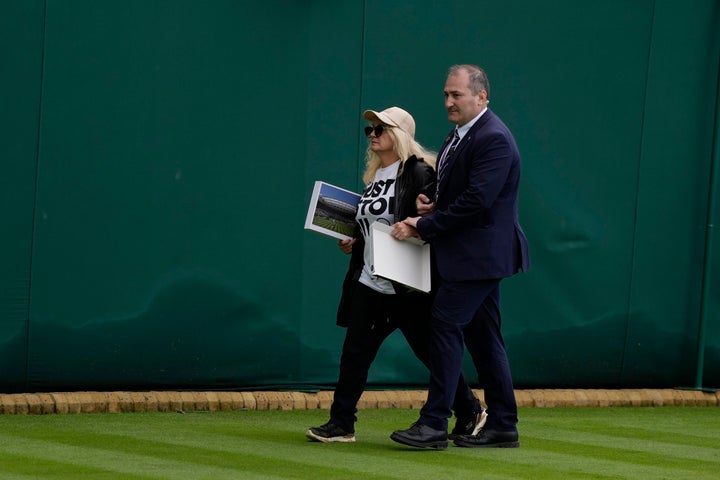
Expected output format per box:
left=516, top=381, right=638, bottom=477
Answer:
left=390, top=65, right=529, bottom=449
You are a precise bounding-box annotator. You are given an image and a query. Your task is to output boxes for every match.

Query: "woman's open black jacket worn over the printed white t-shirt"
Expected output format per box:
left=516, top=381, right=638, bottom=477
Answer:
left=337, top=155, right=436, bottom=327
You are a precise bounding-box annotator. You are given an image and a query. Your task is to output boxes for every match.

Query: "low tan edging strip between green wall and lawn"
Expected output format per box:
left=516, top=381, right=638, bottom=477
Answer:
left=0, top=389, right=720, bottom=415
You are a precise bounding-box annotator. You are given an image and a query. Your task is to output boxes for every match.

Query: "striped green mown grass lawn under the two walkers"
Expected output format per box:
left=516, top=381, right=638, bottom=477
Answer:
left=0, top=407, right=720, bottom=480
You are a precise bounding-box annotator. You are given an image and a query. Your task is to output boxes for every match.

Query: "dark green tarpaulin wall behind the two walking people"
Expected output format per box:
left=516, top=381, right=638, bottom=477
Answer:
left=0, top=0, right=720, bottom=392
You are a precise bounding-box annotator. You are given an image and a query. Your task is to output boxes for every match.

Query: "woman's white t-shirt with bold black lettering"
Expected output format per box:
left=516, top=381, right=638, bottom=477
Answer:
left=355, top=161, right=400, bottom=294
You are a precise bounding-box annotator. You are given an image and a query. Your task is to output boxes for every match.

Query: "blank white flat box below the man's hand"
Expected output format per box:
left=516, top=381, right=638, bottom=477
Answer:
left=371, top=222, right=430, bottom=292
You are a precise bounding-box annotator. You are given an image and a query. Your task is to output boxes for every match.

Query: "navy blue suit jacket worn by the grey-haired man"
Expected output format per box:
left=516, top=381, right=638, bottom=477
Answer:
left=417, top=109, right=530, bottom=281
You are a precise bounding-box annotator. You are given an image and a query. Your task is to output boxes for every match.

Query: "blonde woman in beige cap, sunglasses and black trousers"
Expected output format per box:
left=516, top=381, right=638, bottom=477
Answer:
left=306, top=107, right=486, bottom=443
